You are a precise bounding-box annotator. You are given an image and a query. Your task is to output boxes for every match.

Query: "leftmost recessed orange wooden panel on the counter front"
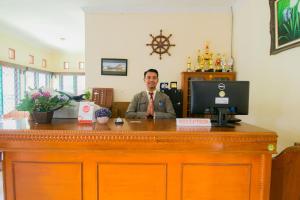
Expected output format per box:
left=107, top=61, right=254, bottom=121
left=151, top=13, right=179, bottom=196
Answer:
left=12, top=161, right=82, bottom=200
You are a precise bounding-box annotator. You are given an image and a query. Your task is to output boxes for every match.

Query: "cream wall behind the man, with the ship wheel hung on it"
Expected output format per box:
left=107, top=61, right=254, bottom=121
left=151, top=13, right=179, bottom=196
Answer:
left=85, top=11, right=231, bottom=101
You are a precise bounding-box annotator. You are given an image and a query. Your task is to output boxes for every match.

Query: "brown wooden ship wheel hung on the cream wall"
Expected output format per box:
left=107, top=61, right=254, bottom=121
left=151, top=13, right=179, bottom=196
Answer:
left=146, top=30, right=175, bottom=60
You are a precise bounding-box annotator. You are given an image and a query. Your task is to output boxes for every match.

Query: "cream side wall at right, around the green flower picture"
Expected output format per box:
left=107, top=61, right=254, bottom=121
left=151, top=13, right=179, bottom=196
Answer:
left=234, top=0, right=300, bottom=151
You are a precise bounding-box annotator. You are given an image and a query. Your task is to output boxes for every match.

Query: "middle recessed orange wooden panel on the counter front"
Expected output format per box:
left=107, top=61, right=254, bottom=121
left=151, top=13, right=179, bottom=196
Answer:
left=98, top=163, right=167, bottom=200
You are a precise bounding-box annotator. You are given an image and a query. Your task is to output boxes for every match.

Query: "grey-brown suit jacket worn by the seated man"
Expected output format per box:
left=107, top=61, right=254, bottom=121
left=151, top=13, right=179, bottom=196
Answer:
left=126, top=91, right=176, bottom=119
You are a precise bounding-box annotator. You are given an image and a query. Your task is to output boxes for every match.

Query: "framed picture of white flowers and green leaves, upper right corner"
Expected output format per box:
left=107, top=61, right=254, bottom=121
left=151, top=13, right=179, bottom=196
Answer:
left=269, top=0, right=300, bottom=55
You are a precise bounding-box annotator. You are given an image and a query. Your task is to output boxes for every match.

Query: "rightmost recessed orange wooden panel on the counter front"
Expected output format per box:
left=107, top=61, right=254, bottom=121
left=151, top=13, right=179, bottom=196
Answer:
left=182, top=163, right=251, bottom=200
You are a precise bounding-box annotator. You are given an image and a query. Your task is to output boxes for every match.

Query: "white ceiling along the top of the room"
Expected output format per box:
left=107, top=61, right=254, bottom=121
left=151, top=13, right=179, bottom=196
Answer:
left=0, top=0, right=236, bottom=53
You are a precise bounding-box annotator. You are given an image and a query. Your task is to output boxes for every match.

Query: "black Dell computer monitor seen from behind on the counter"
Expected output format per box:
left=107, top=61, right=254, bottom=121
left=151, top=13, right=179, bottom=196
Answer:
left=190, top=80, right=249, bottom=126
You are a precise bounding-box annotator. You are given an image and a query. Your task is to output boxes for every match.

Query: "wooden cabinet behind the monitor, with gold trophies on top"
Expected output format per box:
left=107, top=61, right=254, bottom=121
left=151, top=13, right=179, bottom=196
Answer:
left=181, top=72, right=236, bottom=117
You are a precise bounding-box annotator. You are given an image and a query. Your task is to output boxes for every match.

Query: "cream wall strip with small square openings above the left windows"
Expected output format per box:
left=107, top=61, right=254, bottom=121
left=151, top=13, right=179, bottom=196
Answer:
left=0, top=27, right=85, bottom=72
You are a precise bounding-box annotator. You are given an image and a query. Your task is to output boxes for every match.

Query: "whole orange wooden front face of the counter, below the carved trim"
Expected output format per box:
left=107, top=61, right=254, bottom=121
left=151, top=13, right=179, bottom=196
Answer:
left=4, top=150, right=271, bottom=200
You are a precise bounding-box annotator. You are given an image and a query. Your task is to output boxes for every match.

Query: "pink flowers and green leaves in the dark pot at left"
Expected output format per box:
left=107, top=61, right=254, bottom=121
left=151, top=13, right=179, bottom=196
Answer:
left=17, top=88, right=71, bottom=113
